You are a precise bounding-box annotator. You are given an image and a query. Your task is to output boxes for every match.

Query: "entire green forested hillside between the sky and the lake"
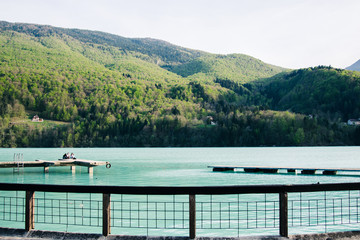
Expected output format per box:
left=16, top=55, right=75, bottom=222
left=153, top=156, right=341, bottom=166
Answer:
left=0, top=22, right=360, bottom=147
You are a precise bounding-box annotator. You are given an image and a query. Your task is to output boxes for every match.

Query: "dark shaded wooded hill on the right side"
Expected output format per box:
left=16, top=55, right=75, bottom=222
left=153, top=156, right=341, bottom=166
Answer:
left=261, top=66, right=360, bottom=121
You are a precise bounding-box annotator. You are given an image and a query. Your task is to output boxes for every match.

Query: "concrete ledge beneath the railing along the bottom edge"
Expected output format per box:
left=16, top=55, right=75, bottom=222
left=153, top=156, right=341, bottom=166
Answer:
left=0, top=227, right=360, bottom=240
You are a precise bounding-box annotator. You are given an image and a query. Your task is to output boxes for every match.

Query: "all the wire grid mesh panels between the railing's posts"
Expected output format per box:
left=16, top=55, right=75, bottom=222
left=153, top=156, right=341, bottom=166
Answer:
left=0, top=191, right=360, bottom=235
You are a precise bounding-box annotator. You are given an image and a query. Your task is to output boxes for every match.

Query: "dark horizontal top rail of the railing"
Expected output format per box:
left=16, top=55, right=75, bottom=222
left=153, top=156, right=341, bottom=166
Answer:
left=0, top=182, right=360, bottom=195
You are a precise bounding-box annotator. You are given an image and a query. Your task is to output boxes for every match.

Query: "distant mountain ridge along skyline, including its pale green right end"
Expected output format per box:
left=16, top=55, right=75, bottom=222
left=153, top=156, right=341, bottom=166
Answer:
left=0, top=21, right=286, bottom=82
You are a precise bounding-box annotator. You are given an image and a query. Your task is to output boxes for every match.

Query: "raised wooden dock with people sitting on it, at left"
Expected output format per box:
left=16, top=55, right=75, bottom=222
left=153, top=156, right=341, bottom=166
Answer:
left=0, top=158, right=111, bottom=173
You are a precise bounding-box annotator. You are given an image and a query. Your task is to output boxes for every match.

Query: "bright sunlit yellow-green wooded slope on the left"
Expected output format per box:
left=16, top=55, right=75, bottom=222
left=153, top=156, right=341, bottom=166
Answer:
left=0, top=28, right=200, bottom=121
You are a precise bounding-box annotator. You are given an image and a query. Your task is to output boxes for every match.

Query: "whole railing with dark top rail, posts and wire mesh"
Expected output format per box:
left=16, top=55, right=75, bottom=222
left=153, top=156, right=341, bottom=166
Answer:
left=0, top=183, right=360, bottom=236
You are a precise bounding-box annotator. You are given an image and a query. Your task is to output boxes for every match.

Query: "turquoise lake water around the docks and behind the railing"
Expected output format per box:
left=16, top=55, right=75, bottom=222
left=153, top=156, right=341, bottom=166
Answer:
left=0, top=147, right=360, bottom=236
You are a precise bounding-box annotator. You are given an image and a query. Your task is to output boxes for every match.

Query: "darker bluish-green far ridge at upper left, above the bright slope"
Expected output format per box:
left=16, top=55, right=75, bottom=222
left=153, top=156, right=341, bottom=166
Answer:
left=0, top=21, right=205, bottom=65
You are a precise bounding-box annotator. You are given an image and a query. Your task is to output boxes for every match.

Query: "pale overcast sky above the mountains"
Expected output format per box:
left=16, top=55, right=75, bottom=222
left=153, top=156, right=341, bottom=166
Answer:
left=0, top=0, right=360, bottom=68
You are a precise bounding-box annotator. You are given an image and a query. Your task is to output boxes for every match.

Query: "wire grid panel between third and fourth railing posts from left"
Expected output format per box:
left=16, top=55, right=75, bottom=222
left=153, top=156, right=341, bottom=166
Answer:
left=196, top=194, right=279, bottom=230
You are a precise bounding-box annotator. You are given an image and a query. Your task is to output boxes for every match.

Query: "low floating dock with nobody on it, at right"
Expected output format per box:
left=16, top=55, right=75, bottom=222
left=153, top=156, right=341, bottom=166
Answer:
left=208, top=166, right=360, bottom=175
